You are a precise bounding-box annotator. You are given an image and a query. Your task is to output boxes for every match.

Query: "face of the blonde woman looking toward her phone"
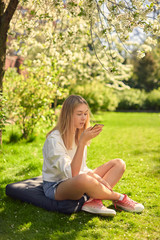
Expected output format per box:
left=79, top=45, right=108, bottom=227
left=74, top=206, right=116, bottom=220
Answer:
left=73, top=103, right=89, bottom=130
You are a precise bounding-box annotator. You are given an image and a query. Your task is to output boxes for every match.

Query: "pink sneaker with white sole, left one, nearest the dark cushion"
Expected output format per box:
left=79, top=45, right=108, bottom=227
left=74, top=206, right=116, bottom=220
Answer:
left=82, top=199, right=116, bottom=217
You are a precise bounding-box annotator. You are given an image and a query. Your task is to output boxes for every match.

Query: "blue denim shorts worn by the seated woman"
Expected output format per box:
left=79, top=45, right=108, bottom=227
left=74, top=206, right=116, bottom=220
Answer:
left=43, top=180, right=63, bottom=200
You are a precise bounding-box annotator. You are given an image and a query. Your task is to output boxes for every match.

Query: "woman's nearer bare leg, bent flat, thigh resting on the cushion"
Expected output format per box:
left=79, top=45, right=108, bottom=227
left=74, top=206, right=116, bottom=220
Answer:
left=55, top=174, right=120, bottom=200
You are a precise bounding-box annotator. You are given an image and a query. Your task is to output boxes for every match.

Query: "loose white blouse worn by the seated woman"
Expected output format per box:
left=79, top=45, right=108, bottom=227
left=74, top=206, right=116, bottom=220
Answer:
left=42, top=130, right=92, bottom=182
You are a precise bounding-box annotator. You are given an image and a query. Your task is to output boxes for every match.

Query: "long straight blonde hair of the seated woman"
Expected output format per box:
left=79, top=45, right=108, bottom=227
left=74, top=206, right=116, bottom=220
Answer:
left=47, top=95, right=90, bottom=149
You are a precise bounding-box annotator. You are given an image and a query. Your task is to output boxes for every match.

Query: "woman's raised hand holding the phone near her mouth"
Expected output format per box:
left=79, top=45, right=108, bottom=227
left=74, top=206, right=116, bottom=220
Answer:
left=79, top=126, right=102, bottom=145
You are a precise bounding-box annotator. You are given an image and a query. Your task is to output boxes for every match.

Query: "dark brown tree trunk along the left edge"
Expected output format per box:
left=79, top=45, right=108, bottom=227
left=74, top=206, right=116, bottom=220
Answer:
left=0, top=0, right=19, bottom=144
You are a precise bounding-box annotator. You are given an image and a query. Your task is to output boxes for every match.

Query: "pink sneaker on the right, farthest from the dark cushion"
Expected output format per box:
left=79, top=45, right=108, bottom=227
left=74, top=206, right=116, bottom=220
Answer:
left=113, top=194, right=144, bottom=212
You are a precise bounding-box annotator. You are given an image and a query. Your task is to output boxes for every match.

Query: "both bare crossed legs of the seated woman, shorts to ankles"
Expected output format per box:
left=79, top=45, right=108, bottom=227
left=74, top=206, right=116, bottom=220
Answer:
left=55, top=159, right=125, bottom=200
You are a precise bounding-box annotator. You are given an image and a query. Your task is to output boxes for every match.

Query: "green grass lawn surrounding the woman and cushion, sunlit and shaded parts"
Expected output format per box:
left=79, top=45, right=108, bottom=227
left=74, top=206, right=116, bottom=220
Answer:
left=0, top=113, right=160, bottom=240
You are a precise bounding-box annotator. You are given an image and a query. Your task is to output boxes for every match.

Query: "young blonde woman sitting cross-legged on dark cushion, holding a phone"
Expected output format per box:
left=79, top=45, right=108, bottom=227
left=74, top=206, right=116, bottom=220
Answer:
left=42, top=95, right=144, bottom=216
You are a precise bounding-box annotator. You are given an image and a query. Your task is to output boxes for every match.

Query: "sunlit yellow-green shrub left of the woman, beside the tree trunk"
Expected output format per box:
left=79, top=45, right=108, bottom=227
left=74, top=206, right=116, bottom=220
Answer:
left=4, top=67, right=67, bottom=139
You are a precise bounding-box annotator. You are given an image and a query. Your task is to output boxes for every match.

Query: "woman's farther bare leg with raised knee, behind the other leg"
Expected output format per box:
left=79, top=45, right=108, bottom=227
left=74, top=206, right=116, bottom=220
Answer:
left=93, top=159, right=126, bottom=188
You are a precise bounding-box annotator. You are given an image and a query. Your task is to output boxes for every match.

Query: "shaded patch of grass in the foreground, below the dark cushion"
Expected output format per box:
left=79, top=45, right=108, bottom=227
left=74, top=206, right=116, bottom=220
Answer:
left=0, top=182, right=113, bottom=240
